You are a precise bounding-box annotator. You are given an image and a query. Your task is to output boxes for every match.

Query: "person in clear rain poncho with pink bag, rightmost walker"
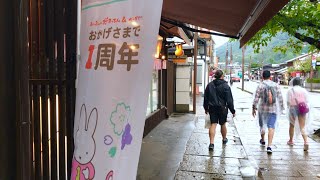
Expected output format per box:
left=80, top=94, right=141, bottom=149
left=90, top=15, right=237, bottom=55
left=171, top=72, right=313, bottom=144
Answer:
left=287, top=77, right=311, bottom=151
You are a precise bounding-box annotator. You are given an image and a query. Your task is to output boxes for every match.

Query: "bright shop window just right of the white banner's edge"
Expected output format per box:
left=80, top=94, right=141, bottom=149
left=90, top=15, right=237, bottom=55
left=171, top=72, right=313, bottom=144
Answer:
left=147, top=70, right=159, bottom=115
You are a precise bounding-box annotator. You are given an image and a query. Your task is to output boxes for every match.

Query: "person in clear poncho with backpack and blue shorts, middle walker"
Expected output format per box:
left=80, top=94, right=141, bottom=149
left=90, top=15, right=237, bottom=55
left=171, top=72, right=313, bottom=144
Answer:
left=252, top=70, right=284, bottom=154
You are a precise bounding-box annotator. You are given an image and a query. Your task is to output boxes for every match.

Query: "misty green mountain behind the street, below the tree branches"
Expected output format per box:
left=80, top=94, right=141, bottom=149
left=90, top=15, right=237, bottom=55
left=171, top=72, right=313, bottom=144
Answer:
left=216, top=33, right=308, bottom=64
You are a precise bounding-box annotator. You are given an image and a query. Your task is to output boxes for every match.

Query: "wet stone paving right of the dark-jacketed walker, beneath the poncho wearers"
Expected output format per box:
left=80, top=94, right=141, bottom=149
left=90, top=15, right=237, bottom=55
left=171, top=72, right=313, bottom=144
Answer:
left=235, top=90, right=320, bottom=179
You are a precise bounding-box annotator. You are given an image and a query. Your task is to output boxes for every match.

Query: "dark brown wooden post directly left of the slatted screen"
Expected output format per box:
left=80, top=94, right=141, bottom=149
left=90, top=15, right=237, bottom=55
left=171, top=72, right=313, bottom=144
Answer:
left=13, top=0, right=32, bottom=180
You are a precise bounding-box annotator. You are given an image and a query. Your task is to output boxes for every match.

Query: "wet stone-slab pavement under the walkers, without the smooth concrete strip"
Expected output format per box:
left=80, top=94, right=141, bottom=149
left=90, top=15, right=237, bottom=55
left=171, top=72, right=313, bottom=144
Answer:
left=174, top=88, right=320, bottom=180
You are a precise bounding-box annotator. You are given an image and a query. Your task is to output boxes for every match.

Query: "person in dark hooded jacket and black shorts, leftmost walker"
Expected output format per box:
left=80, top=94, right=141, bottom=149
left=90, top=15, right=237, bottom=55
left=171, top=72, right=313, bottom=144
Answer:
left=203, top=70, right=236, bottom=151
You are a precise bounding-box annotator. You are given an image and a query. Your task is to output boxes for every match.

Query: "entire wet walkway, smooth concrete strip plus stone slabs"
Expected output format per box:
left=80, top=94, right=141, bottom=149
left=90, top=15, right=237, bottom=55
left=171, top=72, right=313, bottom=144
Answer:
left=137, top=87, right=320, bottom=180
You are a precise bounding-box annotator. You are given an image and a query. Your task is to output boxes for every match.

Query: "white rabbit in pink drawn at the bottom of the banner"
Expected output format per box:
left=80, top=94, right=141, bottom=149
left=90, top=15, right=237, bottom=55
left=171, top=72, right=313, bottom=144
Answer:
left=71, top=104, right=98, bottom=180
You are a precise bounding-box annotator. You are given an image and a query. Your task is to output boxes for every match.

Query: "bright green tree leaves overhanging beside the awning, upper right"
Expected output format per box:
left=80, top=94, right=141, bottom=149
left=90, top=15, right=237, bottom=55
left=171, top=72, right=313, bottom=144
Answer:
left=248, top=0, right=320, bottom=53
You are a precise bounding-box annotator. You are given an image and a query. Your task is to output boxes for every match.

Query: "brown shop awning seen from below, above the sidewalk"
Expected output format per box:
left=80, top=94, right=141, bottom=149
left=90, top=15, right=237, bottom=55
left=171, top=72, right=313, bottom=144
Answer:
left=162, top=0, right=289, bottom=46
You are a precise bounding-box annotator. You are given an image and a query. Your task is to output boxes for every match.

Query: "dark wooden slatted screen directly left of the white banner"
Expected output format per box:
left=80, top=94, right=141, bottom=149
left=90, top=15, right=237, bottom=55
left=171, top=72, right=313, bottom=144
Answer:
left=27, top=0, right=77, bottom=180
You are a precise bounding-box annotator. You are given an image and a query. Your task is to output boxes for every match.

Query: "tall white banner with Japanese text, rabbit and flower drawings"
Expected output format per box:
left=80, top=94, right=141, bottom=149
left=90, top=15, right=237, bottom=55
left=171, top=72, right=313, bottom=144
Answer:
left=71, top=0, right=162, bottom=180
